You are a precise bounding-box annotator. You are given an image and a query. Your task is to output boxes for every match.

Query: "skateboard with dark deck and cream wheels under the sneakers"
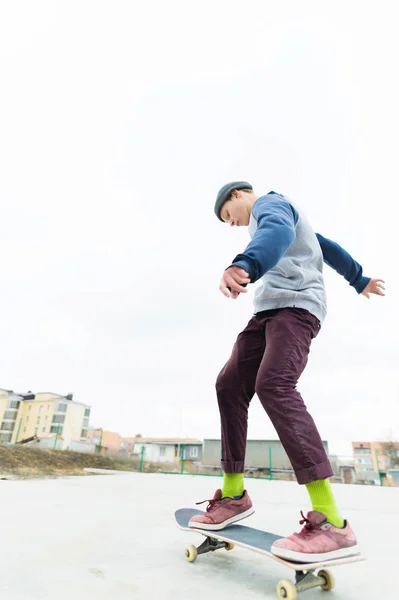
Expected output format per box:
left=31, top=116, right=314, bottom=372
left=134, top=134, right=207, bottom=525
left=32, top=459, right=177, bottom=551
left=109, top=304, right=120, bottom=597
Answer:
left=175, top=508, right=365, bottom=600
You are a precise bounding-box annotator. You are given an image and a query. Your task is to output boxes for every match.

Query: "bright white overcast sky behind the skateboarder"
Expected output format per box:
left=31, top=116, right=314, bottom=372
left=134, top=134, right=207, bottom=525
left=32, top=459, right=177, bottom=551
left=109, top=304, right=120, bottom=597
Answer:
left=0, top=0, right=399, bottom=454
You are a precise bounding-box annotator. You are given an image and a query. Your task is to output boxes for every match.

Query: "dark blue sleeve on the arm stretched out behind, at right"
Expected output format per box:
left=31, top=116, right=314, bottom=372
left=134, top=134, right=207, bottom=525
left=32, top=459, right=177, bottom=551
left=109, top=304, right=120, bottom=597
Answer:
left=316, top=233, right=370, bottom=294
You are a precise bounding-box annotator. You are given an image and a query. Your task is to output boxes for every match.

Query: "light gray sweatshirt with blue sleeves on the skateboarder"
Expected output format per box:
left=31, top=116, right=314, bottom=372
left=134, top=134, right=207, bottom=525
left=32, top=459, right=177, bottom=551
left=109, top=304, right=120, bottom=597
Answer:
left=230, top=192, right=370, bottom=322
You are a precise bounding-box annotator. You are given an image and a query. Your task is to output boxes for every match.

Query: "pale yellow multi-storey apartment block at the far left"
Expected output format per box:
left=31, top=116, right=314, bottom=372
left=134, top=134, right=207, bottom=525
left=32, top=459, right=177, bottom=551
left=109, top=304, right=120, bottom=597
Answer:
left=0, top=389, right=90, bottom=449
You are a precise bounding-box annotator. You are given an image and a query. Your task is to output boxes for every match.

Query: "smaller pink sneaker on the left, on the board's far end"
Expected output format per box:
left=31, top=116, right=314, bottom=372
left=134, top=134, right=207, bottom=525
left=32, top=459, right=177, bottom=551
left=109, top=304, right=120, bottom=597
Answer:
left=189, top=490, right=255, bottom=530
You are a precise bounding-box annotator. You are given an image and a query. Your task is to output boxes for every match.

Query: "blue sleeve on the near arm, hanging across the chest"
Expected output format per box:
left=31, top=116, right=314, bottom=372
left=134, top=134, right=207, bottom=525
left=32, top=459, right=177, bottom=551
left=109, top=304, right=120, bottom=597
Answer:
left=230, top=196, right=298, bottom=283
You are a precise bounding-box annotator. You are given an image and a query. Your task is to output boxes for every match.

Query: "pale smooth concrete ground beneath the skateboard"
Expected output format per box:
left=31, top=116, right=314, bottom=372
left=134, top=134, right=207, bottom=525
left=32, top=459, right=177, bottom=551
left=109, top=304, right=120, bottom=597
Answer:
left=0, top=473, right=399, bottom=600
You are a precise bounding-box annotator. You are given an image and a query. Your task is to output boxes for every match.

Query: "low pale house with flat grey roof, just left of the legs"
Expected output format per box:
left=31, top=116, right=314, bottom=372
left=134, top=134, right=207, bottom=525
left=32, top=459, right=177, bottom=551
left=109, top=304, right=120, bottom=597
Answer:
left=133, top=437, right=202, bottom=463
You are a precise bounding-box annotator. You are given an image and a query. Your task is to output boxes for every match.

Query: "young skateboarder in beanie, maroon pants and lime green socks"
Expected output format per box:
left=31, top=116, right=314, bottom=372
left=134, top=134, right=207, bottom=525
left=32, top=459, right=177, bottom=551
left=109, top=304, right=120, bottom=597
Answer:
left=190, top=181, right=385, bottom=561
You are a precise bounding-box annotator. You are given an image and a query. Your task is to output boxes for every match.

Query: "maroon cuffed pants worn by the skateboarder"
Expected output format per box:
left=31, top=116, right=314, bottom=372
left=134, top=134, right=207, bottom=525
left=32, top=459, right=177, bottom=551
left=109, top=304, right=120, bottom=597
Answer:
left=216, top=308, right=333, bottom=484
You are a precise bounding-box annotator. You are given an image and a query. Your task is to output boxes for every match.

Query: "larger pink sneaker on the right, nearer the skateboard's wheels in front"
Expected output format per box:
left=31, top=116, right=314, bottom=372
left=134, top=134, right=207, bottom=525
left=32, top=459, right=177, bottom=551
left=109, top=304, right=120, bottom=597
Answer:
left=271, top=510, right=360, bottom=562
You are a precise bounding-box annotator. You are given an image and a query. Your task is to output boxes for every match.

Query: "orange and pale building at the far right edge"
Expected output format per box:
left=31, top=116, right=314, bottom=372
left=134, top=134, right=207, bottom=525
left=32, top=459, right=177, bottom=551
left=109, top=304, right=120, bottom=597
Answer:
left=352, top=442, right=399, bottom=483
